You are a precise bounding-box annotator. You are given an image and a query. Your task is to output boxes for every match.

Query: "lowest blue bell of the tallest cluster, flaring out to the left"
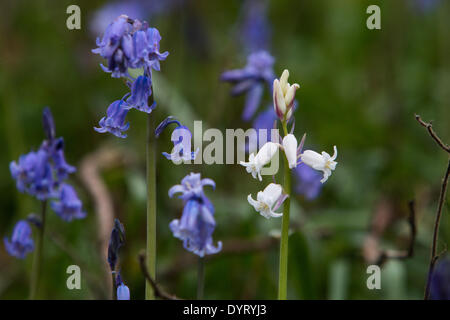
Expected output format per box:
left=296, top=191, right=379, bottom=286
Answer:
left=94, top=100, right=130, bottom=138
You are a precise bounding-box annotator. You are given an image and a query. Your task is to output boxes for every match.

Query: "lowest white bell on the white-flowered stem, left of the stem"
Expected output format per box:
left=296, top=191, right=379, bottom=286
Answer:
left=247, top=183, right=286, bottom=219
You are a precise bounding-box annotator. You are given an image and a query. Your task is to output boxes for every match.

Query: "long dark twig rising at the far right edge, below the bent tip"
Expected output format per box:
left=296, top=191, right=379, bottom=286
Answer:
left=424, top=158, right=450, bottom=300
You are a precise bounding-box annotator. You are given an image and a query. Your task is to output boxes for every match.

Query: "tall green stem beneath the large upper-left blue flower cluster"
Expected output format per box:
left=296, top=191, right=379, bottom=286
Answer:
left=145, top=101, right=156, bottom=300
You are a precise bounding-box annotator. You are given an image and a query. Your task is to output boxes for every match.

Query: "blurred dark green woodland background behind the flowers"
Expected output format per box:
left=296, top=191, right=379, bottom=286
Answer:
left=0, top=0, right=450, bottom=299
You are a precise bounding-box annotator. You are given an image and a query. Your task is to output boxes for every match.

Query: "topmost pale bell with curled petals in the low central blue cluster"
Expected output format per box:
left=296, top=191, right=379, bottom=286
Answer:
left=169, top=172, right=216, bottom=201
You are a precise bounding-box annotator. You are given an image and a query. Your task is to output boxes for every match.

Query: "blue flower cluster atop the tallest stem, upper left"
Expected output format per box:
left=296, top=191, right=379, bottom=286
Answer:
left=92, top=15, right=169, bottom=138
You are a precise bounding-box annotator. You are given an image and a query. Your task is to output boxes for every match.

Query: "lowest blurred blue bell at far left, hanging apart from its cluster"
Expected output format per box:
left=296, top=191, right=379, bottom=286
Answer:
left=4, top=220, right=34, bottom=259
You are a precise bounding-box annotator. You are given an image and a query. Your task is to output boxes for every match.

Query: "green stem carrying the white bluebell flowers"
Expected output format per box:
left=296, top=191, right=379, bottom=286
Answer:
left=278, top=121, right=291, bottom=300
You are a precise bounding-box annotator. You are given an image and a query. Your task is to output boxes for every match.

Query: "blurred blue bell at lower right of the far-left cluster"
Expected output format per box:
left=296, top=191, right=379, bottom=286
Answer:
left=51, top=183, right=86, bottom=222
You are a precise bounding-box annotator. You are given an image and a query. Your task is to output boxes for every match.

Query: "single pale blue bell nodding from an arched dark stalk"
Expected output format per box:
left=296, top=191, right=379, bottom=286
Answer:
left=162, top=126, right=199, bottom=163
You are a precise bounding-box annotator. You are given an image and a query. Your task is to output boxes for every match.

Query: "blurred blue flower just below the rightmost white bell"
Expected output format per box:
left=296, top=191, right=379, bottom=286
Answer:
left=295, top=163, right=323, bottom=200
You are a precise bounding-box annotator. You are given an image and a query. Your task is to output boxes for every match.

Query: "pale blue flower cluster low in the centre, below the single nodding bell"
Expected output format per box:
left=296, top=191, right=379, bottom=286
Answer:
left=169, top=173, right=222, bottom=257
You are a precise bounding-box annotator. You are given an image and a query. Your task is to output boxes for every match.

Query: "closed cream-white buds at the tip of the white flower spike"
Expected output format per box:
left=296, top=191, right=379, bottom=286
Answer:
left=273, top=70, right=300, bottom=121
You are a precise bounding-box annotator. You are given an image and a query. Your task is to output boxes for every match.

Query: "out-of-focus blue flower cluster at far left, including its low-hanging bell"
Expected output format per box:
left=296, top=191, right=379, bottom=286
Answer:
left=5, top=108, right=86, bottom=258
